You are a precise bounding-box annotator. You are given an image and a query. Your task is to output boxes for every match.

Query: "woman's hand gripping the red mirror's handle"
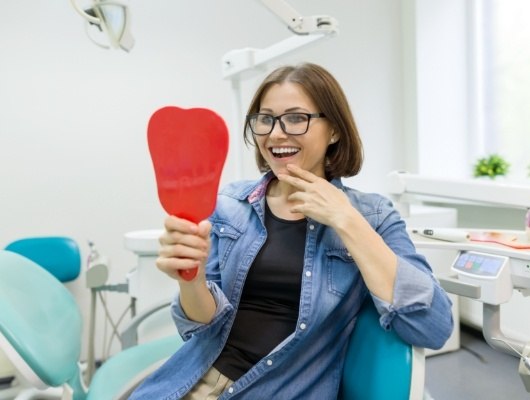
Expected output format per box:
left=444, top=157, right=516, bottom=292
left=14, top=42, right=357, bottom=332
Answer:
left=156, top=216, right=211, bottom=284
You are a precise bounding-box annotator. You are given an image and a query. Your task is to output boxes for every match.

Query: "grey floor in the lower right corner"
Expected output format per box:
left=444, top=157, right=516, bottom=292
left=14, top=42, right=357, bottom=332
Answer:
left=425, top=326, right=530, bottom=400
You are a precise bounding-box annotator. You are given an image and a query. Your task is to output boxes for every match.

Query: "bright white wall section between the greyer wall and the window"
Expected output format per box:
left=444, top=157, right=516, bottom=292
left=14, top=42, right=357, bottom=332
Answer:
left=403, top=0, right=470, bottom=178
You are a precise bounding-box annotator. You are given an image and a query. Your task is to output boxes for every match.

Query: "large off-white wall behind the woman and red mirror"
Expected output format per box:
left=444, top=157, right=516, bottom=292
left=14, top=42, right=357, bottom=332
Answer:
left=0, top=0, right=404, bottom=360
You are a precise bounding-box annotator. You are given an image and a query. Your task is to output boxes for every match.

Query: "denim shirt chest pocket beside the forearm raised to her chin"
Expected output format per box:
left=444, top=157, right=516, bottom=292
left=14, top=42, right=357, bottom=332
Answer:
left=326, top=249, right=359, bottom=297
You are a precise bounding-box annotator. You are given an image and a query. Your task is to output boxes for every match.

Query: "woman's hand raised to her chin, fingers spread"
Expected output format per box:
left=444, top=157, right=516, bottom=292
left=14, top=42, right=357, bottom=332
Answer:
left=278, top=164, right=355, bottom=227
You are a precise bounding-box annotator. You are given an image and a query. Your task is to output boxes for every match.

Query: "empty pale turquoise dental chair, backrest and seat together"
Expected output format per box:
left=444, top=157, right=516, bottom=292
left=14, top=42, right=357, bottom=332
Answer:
left=0, top=250, right=182, bottom=400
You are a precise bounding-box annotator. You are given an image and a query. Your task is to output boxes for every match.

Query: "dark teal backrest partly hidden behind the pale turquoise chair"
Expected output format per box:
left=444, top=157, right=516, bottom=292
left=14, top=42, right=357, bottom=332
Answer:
left=5, top=236, right=81, bottom=282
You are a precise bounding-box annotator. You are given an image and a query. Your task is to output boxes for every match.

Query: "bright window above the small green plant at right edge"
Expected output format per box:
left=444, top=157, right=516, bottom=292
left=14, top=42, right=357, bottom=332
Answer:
left=474, top=0, right=530, bottom=182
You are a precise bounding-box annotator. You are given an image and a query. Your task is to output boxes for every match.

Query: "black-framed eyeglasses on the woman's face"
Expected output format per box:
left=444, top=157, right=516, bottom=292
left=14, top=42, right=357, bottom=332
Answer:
left=247, top=113, right=326, bottom=136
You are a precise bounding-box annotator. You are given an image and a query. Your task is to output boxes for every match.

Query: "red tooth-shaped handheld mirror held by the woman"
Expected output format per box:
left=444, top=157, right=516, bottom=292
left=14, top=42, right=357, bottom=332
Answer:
left=147, top=106, right=228, bottom=280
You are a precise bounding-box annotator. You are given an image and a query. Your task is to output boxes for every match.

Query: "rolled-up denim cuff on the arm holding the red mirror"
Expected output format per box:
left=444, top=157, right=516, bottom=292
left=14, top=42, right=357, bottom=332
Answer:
left=171, top=281, right=234, bottom=340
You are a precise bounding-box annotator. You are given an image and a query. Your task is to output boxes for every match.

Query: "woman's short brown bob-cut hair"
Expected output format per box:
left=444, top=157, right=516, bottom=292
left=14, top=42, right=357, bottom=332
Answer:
left=244, top=63, right=363, bottom=179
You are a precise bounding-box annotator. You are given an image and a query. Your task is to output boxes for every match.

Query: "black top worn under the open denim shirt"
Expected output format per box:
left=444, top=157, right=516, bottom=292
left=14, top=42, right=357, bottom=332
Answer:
left=214, top=206, right=307, bottom=381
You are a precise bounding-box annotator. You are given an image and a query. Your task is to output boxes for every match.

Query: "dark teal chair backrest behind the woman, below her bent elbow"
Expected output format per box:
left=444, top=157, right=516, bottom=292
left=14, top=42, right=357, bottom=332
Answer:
left=341, top=297, right=425, bottom=400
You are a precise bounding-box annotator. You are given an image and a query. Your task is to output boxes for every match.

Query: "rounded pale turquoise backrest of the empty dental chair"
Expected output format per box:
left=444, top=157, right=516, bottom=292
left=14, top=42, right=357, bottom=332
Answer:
left=0, top=250, right=82, bottom=394
